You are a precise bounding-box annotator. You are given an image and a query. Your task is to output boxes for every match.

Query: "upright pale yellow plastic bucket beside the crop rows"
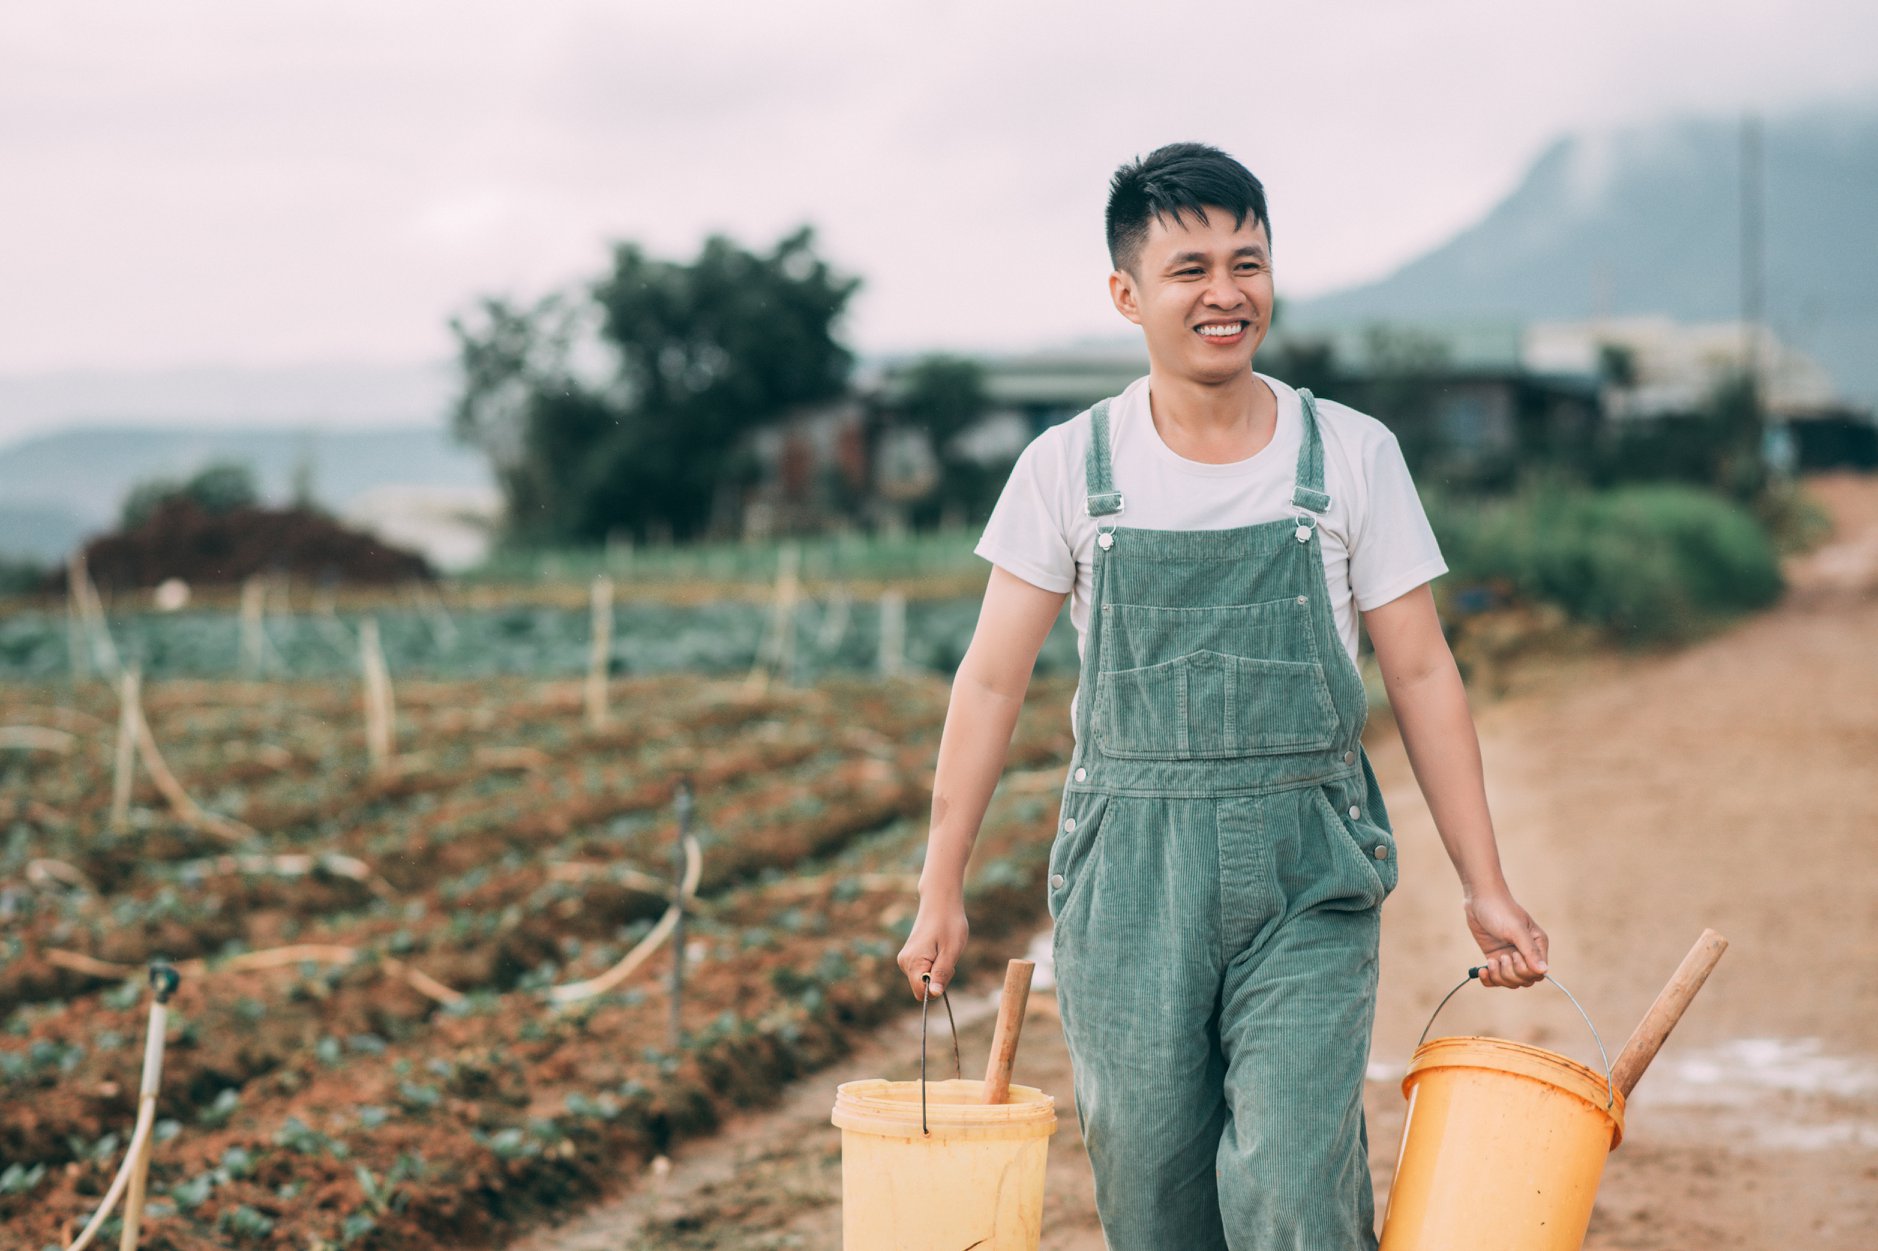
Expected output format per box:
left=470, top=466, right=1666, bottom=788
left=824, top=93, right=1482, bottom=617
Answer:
left=832, top=1078, right=1055, bottom=1251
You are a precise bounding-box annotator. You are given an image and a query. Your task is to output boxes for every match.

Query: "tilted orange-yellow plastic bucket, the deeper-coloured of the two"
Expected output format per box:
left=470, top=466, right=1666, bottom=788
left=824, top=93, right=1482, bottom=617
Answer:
left=1382, top=979, right=1624, bottom=1251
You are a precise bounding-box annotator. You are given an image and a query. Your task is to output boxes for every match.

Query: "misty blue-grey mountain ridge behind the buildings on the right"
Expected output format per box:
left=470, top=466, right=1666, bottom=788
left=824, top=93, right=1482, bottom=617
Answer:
left=1286, top=101, right=1878, bottom=404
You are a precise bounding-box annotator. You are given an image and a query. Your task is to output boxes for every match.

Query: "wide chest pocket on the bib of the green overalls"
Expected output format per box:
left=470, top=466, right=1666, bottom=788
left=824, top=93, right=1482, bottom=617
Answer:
left=1091, top=599, right=1337, bottom=761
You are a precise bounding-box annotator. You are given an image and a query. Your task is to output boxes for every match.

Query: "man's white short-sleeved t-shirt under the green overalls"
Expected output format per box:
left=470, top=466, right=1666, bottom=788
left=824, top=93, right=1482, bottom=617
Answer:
left=973, top=374, right=1448, bottom=683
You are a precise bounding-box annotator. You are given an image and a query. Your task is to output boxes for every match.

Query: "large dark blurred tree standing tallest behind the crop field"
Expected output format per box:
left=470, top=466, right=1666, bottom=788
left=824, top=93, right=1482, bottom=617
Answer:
left=451, top=225, right=860, bottom=543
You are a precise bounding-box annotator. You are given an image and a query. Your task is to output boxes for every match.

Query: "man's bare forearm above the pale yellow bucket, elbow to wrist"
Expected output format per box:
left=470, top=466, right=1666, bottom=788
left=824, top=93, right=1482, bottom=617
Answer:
left=920, top=669, right=1024, bottom=896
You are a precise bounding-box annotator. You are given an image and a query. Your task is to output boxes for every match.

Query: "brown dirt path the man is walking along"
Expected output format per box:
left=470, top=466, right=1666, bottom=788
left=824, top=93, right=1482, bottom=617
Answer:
left=513, top=469, right=1878, bottom=1251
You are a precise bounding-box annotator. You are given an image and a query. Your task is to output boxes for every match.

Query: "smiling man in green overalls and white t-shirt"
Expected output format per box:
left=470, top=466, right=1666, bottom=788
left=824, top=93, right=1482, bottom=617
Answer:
left=900, top=143, right=1546, bottom=1251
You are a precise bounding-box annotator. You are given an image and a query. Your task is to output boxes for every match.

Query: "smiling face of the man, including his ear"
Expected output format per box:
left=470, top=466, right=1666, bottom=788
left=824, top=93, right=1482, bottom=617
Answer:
left=1108, top=207, right=1271, bottom=381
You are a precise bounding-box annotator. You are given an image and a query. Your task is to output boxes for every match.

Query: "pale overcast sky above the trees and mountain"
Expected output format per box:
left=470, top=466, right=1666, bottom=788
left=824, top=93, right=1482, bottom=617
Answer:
left=0, top=0, right=1878, bottom=374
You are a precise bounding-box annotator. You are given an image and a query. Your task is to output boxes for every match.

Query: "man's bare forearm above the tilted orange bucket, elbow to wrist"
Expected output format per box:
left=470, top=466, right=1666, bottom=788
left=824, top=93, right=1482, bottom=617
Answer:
left=1386, top=650, right=1506, bottom=896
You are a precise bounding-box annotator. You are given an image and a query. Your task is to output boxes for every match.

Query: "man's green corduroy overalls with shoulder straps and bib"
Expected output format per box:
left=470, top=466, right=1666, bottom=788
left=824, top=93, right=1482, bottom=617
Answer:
left=1050, top=391, right=1397, bottom=1251
